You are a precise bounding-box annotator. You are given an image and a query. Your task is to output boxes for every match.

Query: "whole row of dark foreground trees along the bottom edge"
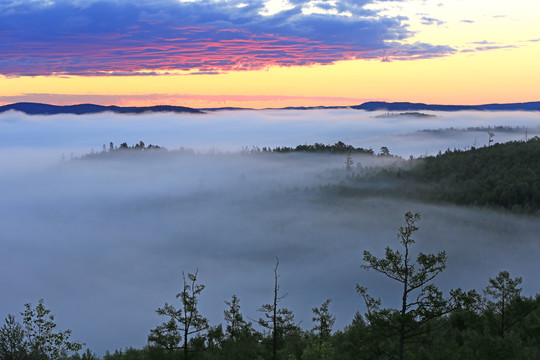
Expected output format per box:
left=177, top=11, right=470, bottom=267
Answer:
left=0, top=212, right=540, bottom=360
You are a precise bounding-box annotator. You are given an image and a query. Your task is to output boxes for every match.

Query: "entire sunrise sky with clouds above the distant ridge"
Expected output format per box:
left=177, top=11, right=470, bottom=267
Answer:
left=0, top=0, right=540, bottom=108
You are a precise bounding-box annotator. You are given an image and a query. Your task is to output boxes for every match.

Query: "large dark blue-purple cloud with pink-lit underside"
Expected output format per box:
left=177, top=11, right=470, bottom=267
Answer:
left=0, top=0, right=454, bottom=76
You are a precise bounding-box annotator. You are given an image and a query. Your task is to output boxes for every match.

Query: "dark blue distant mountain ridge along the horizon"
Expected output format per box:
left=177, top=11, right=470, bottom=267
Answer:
left=0, top=101, right=540, bottom=115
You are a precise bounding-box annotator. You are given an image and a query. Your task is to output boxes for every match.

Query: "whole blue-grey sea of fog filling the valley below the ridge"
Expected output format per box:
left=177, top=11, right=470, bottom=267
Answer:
left=0, top=110, right=540, bottom=354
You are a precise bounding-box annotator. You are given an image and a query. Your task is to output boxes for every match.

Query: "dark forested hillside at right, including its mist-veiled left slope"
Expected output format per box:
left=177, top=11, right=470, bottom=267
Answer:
left=338, top=137, right=540, bottom=214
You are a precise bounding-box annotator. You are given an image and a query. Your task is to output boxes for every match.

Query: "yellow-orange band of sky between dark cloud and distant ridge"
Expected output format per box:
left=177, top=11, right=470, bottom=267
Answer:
left=0, top=42, right=540, bottom=109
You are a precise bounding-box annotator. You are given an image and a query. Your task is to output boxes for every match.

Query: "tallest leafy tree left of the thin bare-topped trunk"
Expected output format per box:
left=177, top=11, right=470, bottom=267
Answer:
left=148, top=270, right=208, bottom=359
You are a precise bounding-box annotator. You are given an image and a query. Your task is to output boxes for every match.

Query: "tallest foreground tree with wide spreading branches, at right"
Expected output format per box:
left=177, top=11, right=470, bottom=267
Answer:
left=357, top=212, right=477, bottom=360
